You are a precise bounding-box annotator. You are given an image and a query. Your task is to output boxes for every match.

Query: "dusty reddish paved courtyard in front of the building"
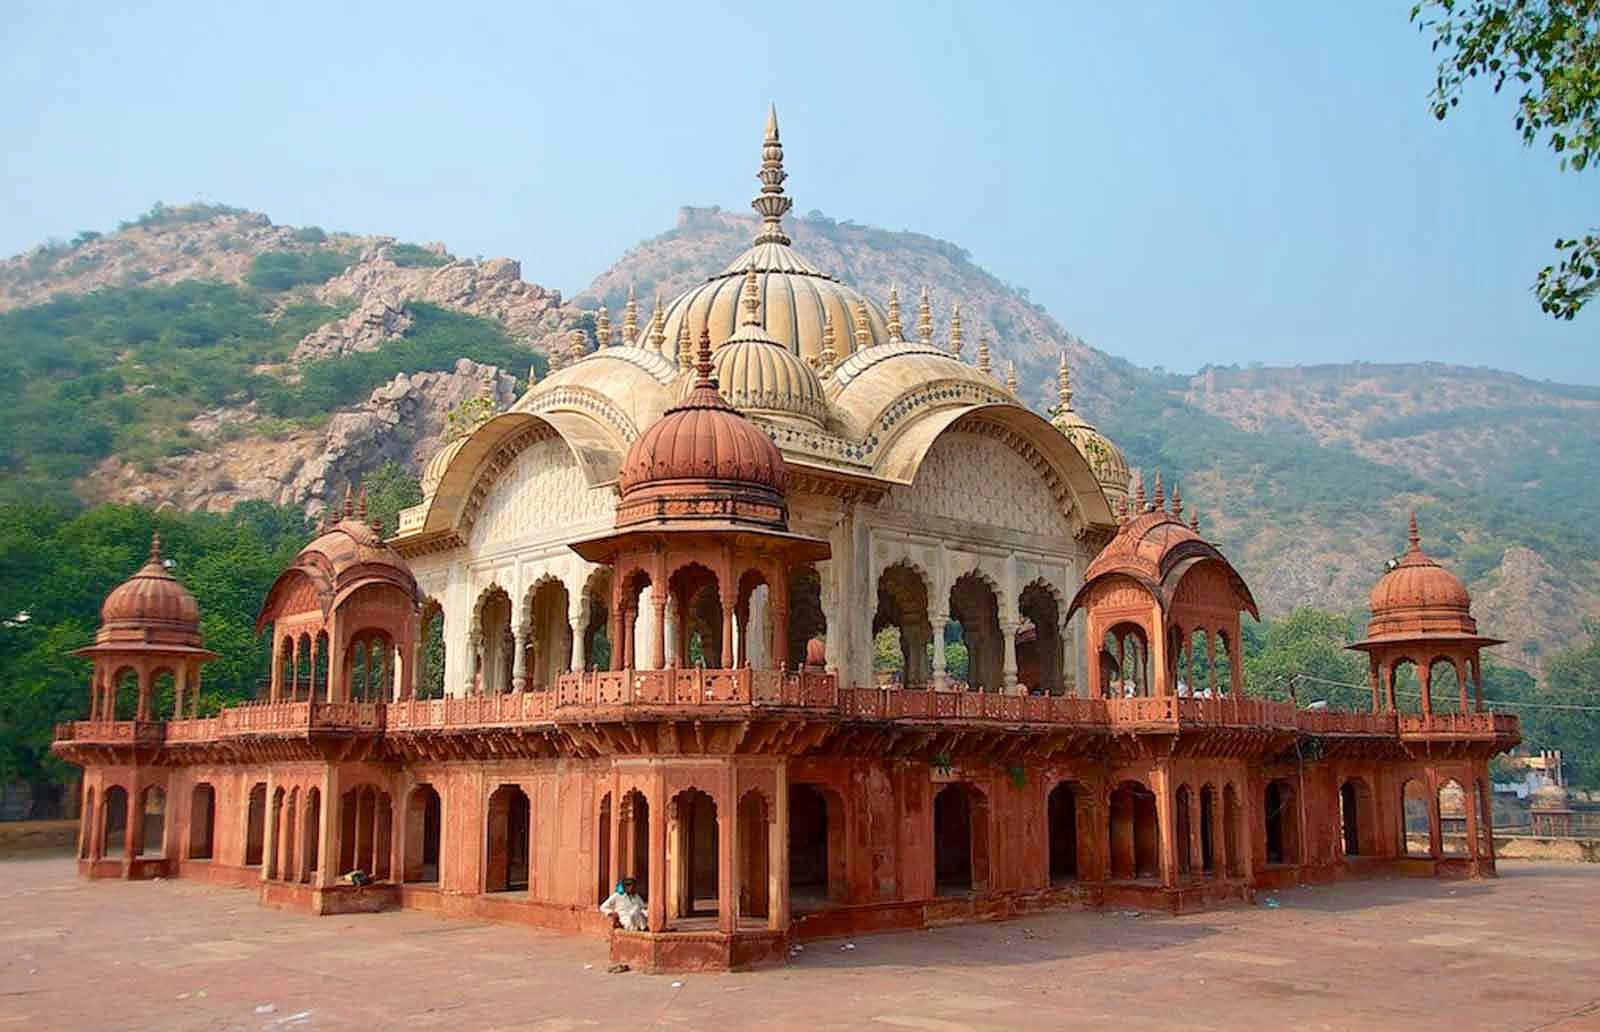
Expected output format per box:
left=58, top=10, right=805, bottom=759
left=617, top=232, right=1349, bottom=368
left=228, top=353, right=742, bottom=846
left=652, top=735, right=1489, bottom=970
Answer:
left=0, top=858, right=1600, bottom=1032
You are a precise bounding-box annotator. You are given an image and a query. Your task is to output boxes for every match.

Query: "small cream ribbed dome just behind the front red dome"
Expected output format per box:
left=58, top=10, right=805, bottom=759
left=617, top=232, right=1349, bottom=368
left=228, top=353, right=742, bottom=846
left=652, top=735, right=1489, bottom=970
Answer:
left=683, top=269, right=827, bottom=427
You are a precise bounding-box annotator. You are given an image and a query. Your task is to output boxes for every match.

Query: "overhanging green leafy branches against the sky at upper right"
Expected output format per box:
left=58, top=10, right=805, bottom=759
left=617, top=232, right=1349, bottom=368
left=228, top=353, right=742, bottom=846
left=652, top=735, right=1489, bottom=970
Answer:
left=1411, top=0, right=1600, bottom=318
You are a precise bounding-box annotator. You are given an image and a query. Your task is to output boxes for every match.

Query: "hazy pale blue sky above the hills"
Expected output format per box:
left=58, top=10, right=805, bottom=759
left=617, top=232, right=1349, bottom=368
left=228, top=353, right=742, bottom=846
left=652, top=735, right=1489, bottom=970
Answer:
left=0, top=0, right=1600, bottom=384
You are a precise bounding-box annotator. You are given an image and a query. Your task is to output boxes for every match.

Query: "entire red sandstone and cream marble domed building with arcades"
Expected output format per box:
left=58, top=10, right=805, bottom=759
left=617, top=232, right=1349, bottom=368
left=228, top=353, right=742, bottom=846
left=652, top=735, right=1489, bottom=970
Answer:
left=54, top=117, right=1518, bottom=970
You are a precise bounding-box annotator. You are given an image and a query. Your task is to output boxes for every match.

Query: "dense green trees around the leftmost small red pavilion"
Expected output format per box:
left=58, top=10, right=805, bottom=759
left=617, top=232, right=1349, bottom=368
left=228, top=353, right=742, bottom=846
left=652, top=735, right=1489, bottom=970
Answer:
left=0, top=502, right=310, bottom=781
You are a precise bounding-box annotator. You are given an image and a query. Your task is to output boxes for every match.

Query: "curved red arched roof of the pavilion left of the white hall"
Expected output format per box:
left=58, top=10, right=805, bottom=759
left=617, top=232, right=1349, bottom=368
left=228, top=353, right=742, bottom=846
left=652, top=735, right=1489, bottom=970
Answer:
left=256, top=496, right=422, bottom=632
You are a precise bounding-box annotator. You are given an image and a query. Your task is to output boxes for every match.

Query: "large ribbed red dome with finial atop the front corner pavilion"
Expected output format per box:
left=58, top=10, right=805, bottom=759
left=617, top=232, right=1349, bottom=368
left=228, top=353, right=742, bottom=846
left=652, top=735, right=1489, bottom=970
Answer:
left=616, top=331, right=789, bottom=530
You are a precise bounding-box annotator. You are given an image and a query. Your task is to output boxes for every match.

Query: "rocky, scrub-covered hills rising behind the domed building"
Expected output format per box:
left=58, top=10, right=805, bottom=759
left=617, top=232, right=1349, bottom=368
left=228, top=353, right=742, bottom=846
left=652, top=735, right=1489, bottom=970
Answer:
left=0, top=208, right=1600, bottom=667
